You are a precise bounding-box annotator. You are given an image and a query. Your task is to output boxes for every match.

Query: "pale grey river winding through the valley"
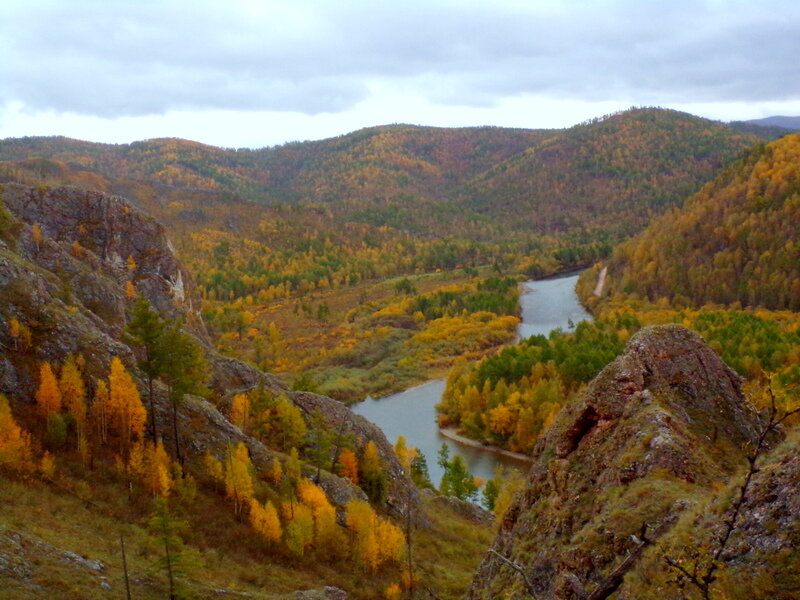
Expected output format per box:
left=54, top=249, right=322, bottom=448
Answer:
left=352, top=273, right=591, bottom=486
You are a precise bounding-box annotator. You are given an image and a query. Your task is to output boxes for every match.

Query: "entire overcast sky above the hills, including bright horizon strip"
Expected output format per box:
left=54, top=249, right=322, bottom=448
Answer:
left=0, top=0, right=800, bottom=147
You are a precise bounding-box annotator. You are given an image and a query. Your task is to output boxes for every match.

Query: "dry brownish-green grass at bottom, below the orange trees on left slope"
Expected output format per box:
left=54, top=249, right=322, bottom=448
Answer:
left=0, top=465, right=492, bottom=600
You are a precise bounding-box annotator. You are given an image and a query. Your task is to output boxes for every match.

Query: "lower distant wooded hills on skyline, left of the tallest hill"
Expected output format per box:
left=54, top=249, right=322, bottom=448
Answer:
left=0, top=125, right=553, bottom=210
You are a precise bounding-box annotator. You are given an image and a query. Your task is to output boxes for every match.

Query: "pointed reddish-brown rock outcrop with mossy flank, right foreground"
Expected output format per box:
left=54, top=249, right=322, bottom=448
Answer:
left=470, top=325, right=762, bottom=600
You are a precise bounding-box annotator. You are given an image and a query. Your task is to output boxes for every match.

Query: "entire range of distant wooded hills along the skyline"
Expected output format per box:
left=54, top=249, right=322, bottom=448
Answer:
left=0, top=109, right=758, bottom=246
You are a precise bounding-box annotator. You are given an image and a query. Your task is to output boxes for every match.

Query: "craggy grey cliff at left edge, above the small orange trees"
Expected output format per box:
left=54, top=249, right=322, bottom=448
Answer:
left=0, top=184, right=198, bottom=400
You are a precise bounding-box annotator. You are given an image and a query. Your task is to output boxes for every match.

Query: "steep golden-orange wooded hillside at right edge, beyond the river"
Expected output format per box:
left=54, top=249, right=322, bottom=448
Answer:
left=609, top=134, right=800, bottom=311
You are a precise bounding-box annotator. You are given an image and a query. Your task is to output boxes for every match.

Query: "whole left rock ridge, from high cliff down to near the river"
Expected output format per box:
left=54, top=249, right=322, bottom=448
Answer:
left=0, top=184, right=419, bottom=513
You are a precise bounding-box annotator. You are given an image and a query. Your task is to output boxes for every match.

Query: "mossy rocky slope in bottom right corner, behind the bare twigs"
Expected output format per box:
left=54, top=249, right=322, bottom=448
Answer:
left=626, top=433, right=800, bottom=600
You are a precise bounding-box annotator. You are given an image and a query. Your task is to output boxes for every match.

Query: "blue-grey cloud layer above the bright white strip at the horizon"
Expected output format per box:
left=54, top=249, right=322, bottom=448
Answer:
left=0, top=0, right=800, bottom=117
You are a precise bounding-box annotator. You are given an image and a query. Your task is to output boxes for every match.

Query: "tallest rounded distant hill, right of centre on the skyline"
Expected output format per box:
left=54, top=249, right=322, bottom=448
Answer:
left=459, top=109, right=755, bottom=240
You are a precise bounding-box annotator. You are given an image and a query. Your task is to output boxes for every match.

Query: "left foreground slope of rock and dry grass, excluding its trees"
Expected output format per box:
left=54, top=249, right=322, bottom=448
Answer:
left=0, top=184, right=462, bottom=598
